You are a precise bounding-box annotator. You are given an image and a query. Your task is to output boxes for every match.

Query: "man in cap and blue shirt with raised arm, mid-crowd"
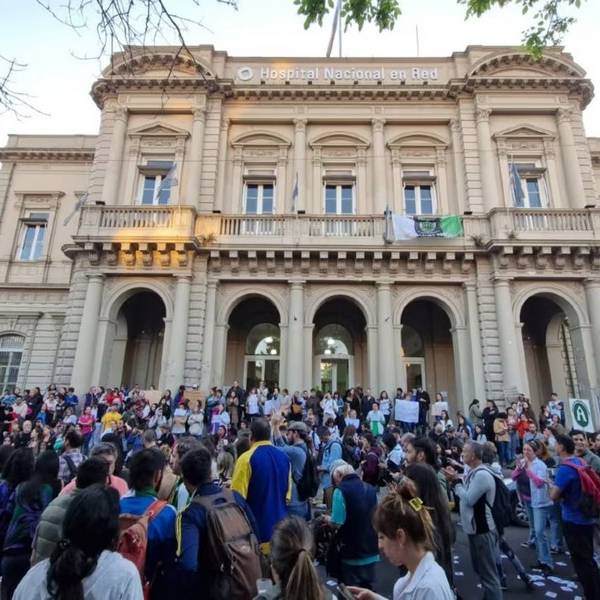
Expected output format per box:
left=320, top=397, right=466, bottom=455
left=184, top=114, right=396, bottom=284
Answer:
left=271, top=415, right=311, bottom=521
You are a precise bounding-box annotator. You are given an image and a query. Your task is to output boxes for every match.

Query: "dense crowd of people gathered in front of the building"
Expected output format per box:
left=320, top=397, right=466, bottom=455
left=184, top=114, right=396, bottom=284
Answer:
left=0, top=382, right=600, bottom=600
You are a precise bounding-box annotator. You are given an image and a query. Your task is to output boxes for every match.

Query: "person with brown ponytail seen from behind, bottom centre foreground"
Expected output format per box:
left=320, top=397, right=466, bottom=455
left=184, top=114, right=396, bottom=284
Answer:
left=255, top=516, right=331, bottom=600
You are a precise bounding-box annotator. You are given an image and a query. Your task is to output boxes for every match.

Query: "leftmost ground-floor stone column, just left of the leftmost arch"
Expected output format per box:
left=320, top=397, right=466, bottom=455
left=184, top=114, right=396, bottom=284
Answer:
left=71, top=274, right=104, bottom=394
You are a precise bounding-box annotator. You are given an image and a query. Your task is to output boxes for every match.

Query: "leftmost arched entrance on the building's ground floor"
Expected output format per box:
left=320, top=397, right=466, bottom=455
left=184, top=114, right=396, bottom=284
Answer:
left=107, top=290, right=166, bottom=389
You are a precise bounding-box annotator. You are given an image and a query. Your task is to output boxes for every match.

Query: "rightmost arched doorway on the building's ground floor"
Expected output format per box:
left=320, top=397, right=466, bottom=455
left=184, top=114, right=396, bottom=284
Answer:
left=520, top=295, right=579, bottom=409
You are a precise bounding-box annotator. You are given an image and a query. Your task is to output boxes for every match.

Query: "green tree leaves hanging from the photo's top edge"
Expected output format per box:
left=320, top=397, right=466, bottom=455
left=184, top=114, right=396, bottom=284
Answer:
left=294, top=0, right=585, bottom=57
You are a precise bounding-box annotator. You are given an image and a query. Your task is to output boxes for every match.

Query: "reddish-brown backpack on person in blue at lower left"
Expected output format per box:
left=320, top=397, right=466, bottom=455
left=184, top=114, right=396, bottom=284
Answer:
left=117, top=500, right=167, bottom=597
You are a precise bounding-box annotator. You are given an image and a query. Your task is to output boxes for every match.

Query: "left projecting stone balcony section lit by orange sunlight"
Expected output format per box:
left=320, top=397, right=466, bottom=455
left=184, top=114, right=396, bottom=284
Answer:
left=76, top=206, right=196, bottom=242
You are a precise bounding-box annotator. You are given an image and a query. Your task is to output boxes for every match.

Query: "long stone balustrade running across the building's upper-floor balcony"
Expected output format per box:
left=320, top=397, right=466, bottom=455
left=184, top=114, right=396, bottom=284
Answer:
left=77, top=206, right=600, bottom=247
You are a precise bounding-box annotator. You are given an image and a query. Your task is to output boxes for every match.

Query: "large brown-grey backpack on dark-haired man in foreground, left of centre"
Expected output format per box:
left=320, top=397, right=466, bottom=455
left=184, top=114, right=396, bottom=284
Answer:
left=192, top=489, right=262, bottom=600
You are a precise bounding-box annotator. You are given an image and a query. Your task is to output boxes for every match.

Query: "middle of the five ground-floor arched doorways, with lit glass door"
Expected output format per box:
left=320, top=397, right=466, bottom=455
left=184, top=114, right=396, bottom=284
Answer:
left=313, top=298, right=368, bottom=394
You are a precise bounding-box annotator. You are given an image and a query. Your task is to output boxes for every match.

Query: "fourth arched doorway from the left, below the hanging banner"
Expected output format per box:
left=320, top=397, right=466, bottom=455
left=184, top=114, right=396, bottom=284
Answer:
left=401, top=300, right=456, bottom=400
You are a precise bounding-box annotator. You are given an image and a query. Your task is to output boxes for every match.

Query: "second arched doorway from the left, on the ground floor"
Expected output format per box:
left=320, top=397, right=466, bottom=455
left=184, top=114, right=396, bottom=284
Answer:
left=225, top=296, right=281, bottom=390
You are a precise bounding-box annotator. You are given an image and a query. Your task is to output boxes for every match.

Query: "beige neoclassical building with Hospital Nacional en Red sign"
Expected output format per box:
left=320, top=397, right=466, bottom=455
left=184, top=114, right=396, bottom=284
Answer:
left=0, top=46, right=600, bottom=420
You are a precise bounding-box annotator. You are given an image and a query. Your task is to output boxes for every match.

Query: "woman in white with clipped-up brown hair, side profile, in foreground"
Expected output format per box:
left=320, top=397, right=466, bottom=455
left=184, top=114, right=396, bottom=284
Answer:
left=348, top=478, right=454, bottom=600
